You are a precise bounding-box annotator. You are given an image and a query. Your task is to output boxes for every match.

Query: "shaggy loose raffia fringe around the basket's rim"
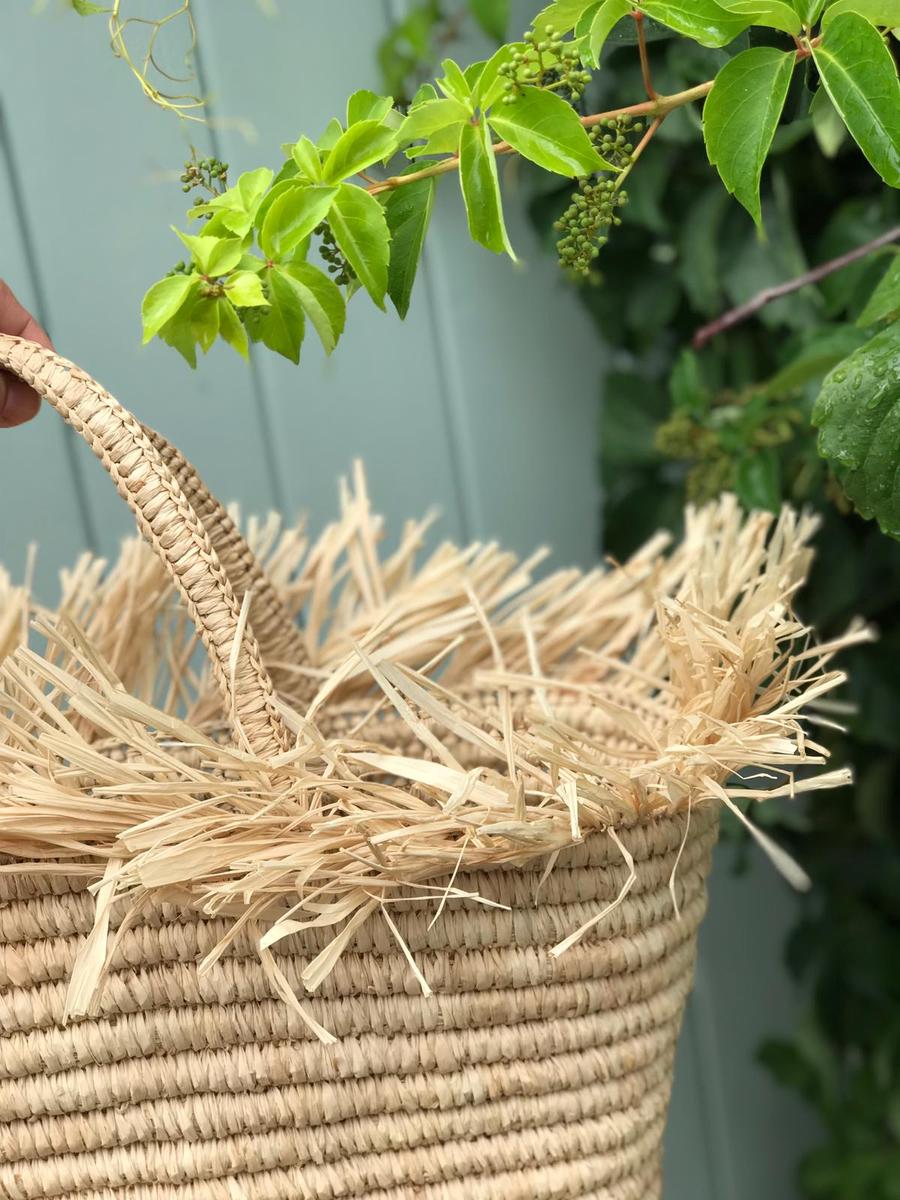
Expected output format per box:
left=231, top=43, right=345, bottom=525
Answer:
left=0, top=472, right=870, bottom=1039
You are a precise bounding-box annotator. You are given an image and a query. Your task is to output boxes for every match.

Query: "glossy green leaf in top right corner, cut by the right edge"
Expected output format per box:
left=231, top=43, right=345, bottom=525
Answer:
left=812, top=12, right=900, bottom=187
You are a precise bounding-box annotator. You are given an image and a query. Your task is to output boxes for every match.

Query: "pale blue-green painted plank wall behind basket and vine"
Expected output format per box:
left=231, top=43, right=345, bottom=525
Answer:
left=0, top=0, right=809, bottom=1200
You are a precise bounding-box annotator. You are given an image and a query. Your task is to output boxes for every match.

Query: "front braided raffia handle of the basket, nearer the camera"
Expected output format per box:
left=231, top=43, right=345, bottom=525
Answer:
left=0, top=334, right=292, bottom=757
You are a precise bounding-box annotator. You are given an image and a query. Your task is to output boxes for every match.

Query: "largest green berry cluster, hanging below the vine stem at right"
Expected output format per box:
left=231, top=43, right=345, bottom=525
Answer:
left=554, top=116, right=642, bottom=278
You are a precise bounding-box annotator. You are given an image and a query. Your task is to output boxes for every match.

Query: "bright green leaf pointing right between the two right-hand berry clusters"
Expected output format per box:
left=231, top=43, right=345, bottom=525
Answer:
left=488, top=88, right=616, bottom=176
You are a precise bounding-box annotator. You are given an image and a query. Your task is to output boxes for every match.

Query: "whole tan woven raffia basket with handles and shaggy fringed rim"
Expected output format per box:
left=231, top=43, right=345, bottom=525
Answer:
left=0, top=336, right=862, bottom=1200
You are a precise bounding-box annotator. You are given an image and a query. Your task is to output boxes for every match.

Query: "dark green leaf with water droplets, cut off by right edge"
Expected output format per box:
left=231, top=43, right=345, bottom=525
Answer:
left=812, top=322, right=900, bottom=538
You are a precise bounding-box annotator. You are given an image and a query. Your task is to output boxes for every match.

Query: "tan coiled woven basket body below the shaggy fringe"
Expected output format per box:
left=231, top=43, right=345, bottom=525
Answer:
left=0, top=805, right=716, bottom=1200
